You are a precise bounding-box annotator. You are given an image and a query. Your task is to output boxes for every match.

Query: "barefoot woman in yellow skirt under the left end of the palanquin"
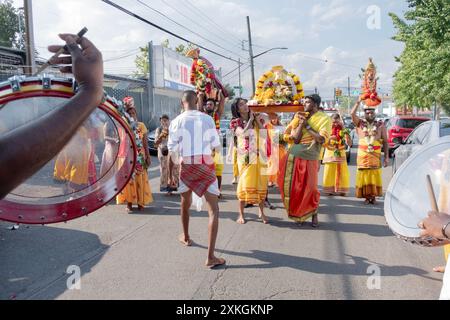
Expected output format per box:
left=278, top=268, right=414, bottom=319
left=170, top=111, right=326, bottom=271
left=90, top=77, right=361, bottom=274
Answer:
left=230, top=98, right=269, bottom=224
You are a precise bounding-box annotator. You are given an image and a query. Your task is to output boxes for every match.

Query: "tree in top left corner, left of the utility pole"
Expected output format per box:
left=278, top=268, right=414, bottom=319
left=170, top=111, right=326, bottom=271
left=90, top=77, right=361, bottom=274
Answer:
left=0, top=0, right=25, bottom=50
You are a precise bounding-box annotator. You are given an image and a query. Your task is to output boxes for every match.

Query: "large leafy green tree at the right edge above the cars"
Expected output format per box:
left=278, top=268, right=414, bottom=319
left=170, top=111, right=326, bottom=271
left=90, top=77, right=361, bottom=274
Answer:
left=390, top=0, right=450, bottom=112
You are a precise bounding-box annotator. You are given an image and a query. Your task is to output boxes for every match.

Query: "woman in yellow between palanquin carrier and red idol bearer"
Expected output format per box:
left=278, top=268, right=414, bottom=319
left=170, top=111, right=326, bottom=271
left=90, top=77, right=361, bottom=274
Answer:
left=323, top=114, right=351, bottom=196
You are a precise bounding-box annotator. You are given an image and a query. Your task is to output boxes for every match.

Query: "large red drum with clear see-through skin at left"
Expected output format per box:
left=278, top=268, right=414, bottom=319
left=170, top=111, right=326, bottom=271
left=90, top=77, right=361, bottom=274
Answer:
left=0, top=76, right=136, bottom=224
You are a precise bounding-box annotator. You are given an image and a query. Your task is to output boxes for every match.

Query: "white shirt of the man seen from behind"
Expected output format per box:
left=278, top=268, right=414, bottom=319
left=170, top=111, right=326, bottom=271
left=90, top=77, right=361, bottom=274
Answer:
left=167, top=111, right=221, bottom=158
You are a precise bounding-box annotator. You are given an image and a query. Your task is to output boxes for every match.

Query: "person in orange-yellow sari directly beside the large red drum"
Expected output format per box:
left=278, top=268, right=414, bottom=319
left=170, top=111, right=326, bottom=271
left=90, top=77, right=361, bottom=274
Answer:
left=117, top=98, right=153, bottom=212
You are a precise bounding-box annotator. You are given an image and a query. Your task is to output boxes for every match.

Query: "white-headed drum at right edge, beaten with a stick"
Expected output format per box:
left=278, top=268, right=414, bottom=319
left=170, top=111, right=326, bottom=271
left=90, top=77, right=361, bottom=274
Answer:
left=384, top=137, right=450, bottom=247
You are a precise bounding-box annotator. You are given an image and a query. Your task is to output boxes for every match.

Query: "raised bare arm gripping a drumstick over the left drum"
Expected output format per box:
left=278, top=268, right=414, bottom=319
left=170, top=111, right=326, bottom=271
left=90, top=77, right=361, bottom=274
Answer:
left=0, top=34, right=103, bottom=199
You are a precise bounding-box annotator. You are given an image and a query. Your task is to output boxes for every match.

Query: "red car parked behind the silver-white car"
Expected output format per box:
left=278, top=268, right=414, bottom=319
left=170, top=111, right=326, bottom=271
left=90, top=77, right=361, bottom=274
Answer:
left=387, top=116, right=430, bottom=157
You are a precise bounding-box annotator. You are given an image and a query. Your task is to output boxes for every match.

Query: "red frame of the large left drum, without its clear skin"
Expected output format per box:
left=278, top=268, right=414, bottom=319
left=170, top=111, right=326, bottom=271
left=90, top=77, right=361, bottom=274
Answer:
left=0, top=75, right=136, bottom=224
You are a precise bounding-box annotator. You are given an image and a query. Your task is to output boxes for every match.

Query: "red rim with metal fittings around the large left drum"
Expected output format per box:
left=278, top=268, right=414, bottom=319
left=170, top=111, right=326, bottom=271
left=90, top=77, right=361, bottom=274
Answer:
left=0, top=77, right=137, bottom=225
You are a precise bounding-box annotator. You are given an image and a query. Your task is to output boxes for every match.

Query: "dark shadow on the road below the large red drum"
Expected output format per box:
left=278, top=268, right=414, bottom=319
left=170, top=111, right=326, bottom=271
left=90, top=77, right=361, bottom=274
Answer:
left=0, top=223, right=108, bottom=300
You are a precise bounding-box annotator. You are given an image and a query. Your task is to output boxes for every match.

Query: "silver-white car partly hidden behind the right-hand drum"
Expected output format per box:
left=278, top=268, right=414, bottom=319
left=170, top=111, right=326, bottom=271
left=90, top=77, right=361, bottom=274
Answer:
left=392, top=119, right=450, bottom=173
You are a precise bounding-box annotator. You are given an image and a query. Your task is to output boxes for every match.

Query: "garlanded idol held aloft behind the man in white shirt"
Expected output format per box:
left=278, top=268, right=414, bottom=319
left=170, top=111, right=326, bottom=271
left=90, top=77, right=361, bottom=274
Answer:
left=186, top=48, right=228, bottom=100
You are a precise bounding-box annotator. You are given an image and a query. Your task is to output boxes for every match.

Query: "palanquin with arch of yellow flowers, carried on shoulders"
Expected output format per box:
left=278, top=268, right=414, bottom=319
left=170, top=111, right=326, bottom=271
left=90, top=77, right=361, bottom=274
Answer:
left=249, top=66, right=305, bottom=113
